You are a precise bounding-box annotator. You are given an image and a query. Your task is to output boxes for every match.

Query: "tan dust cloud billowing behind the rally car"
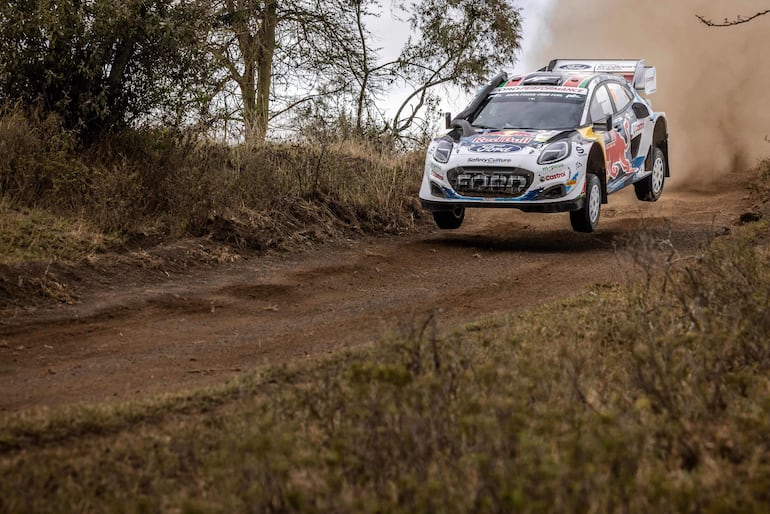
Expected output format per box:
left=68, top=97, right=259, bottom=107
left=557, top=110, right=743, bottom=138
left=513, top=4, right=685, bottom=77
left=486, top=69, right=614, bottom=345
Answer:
left=532, top=0, right=770, bottom=186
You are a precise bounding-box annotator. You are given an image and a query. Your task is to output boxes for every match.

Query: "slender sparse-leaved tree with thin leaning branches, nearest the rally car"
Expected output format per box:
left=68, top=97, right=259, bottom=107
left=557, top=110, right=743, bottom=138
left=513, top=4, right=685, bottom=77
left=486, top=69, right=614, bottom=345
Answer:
left=340, top=0, right=521, bottom=138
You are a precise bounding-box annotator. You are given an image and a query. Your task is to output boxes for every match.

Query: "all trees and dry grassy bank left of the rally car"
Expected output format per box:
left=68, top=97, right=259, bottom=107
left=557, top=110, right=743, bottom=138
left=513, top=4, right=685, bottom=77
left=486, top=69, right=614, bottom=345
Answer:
left=0, top=0, right=521, bottom=300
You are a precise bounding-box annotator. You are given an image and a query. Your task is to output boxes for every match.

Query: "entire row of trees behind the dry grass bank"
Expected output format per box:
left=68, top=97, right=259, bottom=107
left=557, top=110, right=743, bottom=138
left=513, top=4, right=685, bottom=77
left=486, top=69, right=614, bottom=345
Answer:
left=0, top=0, right=521, bottom=144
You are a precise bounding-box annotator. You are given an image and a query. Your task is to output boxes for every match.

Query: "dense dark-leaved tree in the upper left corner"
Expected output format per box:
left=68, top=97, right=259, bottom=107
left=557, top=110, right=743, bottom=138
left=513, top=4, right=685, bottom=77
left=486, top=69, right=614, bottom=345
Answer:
left=0, top=0, right=210, bottom=142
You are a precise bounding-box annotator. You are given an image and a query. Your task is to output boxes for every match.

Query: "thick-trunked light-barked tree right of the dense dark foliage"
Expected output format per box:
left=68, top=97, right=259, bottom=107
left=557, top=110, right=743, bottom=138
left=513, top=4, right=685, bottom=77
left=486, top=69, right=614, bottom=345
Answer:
left=210, top=0, right=364, bottom=139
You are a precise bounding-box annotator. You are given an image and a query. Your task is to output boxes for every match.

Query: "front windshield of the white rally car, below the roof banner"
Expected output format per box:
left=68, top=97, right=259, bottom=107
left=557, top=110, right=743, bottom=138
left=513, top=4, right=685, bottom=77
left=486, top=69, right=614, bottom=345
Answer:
left=471, top=87, right=586, bottom=130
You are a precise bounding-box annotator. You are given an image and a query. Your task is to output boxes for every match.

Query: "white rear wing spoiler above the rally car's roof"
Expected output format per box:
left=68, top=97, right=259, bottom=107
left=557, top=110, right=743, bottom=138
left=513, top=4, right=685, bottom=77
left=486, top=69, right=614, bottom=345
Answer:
left=543, top=59, right=658, bottom=95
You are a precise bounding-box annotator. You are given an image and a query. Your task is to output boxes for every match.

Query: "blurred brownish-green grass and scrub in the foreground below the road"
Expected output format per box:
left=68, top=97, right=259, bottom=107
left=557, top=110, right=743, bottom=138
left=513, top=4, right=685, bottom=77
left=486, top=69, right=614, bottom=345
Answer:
left=0, top=159, right=770, bottom=513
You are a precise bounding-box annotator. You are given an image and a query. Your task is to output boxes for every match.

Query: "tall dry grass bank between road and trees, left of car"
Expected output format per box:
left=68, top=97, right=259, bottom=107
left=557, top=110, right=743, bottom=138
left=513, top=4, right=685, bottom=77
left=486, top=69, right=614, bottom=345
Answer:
left=0, top=105, right=421, bottom=262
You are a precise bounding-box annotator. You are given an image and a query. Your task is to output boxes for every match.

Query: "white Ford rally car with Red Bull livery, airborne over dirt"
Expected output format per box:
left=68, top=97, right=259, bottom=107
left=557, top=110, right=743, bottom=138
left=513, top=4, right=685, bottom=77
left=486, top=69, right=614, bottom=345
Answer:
left=420, top=59, right=669, bottom=232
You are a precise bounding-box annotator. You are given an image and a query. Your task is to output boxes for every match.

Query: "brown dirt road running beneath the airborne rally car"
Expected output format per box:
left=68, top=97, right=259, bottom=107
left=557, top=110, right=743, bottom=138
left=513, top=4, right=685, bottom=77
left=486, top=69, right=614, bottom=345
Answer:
left=0, top=175, right=750, bottom=413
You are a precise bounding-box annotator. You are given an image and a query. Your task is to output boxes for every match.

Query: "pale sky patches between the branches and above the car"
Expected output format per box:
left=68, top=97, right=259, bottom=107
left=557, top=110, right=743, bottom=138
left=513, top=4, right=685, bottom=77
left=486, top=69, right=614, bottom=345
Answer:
left=367, top=0, right=553, bottom=120
